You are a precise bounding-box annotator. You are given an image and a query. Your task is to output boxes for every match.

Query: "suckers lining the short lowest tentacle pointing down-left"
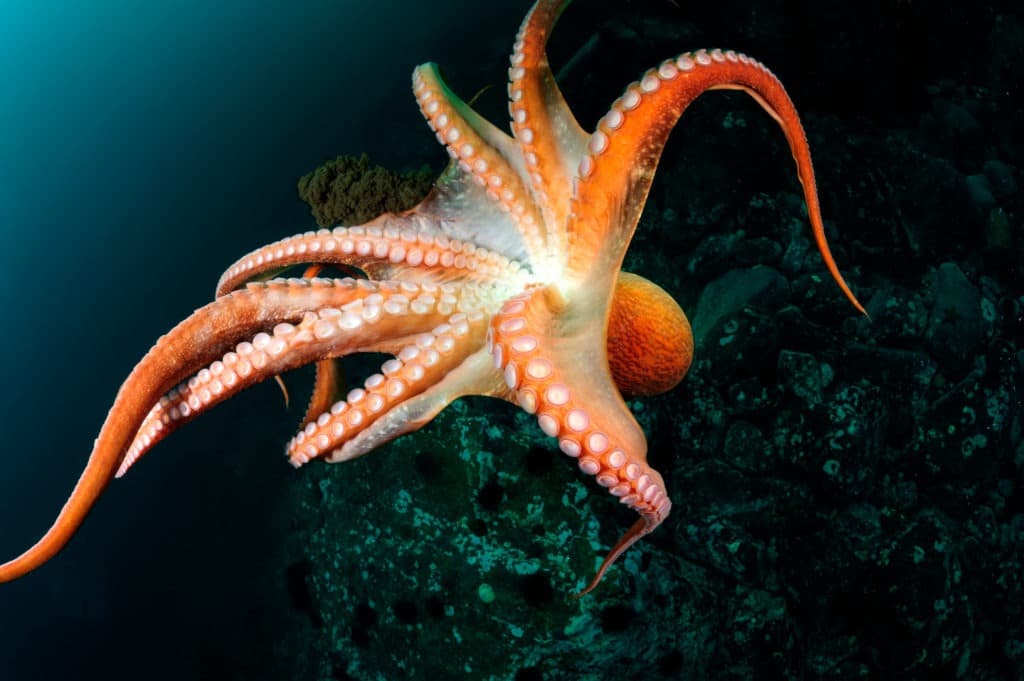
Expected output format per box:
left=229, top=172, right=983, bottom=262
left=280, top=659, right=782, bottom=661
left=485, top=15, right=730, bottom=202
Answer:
left=287, top=310, right=486, bottom=468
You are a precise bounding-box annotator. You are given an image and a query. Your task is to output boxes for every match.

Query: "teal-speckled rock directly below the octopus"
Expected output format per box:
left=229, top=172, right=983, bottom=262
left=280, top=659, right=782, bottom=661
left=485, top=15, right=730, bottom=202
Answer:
left=284, top=399, right=704, bottom=679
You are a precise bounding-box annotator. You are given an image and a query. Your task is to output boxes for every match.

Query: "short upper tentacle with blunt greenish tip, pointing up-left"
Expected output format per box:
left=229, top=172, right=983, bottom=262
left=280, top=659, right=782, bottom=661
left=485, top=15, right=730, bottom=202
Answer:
left=413, top=63, right=545, bottom=262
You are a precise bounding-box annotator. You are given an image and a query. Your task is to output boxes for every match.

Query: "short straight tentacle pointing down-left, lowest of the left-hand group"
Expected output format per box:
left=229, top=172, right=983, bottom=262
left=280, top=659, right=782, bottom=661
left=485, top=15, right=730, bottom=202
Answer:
left=288, top=310, right=486, bottom=467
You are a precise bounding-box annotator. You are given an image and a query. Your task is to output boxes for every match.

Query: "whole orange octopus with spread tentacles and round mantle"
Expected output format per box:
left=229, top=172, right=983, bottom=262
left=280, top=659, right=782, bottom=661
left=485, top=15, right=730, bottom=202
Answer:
left=0, top=0, right=864, bottom=595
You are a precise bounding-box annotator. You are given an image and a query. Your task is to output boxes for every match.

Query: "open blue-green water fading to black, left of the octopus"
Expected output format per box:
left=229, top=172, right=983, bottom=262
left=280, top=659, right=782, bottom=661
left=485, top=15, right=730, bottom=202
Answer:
left=0, top=0, right=521, bottom=681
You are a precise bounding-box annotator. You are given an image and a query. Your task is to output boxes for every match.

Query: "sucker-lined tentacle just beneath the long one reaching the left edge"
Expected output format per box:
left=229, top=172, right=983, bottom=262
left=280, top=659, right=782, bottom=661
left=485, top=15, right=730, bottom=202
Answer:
left=117, top=280, right=491, bottom=477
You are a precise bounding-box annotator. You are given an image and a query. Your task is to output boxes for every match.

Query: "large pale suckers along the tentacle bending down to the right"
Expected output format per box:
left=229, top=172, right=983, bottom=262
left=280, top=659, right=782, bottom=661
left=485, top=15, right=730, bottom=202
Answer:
left=487, top=292, right=672, bottom=524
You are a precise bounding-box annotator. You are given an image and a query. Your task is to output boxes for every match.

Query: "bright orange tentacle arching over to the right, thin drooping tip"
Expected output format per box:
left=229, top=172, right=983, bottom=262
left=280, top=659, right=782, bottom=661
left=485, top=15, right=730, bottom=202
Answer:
left=567, top=49, right=864, bottom=312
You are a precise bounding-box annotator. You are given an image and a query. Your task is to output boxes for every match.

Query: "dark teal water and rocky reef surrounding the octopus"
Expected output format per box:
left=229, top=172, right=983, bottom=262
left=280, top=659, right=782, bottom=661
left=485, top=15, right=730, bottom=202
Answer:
left=0, top=0, right=1024, bottom=681
